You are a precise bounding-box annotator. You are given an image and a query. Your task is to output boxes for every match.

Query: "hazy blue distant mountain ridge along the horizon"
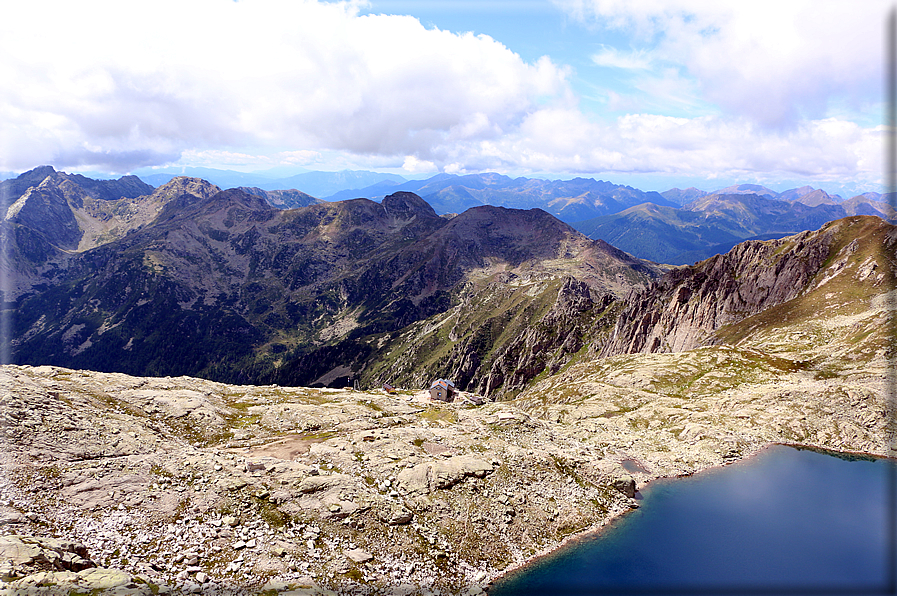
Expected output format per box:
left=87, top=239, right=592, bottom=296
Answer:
left=0, top=166, right=897, bottom=264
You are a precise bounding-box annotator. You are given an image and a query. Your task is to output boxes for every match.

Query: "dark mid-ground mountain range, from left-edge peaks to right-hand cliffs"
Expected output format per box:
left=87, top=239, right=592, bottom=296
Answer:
left=0, top=165, right=894, bottom=396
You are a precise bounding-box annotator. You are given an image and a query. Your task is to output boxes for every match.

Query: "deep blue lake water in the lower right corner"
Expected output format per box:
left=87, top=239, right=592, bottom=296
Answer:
left=489, top=445, right=897, bottom=596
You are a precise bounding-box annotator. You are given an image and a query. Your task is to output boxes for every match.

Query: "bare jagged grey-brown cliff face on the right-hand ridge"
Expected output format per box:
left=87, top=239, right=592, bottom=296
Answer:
left=599, top=217, right=893, bottom=357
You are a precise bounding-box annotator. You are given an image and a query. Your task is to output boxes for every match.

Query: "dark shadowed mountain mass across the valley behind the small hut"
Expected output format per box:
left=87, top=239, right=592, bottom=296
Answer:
left=12, top=178, right=659, bottom=385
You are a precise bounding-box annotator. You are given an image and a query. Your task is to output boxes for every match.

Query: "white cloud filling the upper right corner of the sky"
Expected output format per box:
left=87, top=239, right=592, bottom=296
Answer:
left=556, top=0, right=892, bottom=127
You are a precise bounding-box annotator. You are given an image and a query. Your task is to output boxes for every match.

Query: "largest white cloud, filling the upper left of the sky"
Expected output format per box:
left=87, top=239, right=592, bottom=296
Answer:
left=0, top=0, right=569, bottom=169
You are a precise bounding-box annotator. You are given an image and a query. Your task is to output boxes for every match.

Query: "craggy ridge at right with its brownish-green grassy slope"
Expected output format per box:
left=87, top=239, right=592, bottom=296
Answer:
left=602, top=216, right=897, bottom=355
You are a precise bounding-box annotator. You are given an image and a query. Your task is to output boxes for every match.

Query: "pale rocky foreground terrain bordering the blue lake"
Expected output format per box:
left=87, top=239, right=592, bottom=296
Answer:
left=0, top=328, right=880, bottom=595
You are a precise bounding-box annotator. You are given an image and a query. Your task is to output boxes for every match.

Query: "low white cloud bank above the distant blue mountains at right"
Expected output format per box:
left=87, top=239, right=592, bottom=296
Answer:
left=434, top=109, right=882, bottom=186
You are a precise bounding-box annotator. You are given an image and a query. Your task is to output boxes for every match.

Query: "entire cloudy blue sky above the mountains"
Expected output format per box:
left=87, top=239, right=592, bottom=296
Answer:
left=0, top=0, right=894, bottom=195
